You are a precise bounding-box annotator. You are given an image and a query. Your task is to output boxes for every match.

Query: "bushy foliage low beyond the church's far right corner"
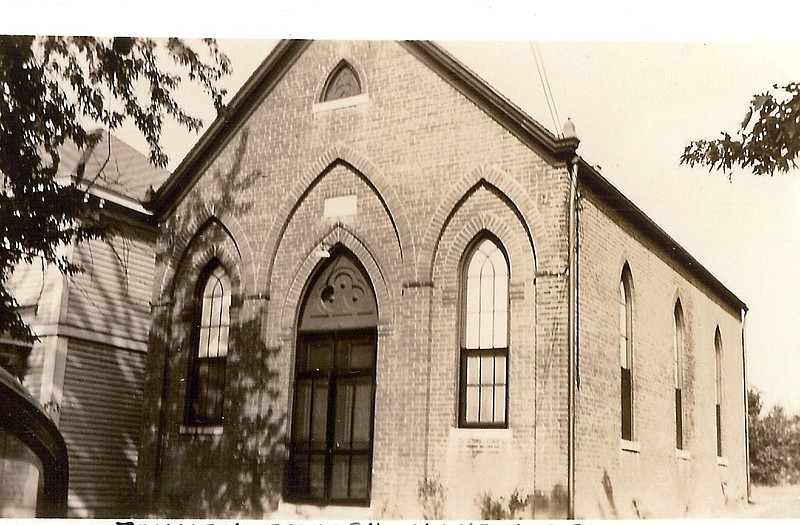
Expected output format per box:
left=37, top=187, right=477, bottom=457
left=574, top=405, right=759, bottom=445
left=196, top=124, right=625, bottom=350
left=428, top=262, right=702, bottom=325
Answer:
left=747, top=388, right=800, bottom=485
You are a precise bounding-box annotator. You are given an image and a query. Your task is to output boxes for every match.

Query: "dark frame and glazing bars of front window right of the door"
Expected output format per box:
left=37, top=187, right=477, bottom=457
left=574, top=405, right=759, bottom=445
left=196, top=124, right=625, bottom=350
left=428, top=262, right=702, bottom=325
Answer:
left=457, top=235, right=511, bottom=429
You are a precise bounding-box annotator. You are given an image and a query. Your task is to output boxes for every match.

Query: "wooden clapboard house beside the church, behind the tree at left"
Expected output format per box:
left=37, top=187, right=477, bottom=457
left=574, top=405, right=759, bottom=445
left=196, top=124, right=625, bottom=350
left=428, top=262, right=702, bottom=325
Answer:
left=2, top=133, right=168, bottom=518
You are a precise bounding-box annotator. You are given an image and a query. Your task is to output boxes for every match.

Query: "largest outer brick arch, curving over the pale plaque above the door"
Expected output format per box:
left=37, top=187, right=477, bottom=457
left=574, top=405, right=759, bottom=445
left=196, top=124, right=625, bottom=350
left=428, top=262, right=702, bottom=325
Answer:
left=256, top=146, right=414, bottom=295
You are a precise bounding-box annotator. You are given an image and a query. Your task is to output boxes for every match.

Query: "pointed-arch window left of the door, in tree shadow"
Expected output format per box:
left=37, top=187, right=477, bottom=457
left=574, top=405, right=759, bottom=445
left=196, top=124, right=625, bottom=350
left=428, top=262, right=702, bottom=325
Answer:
left=186, top=263, right=231, bottom=425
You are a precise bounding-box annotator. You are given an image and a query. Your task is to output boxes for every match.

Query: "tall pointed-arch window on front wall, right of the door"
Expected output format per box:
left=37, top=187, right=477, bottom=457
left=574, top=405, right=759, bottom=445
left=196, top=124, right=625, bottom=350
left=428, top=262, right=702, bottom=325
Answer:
left=459, top=237, right=509, bottom=428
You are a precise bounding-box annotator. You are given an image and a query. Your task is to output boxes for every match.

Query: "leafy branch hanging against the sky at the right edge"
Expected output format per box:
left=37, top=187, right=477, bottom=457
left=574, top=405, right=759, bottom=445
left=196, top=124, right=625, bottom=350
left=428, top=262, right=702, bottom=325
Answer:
left=681, top=82, right=800, bottom=175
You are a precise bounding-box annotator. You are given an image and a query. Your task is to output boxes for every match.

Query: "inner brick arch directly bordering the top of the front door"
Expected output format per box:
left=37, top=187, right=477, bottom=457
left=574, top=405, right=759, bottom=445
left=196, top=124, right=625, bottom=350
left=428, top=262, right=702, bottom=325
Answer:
left=280, top=225, right=395, bottom=339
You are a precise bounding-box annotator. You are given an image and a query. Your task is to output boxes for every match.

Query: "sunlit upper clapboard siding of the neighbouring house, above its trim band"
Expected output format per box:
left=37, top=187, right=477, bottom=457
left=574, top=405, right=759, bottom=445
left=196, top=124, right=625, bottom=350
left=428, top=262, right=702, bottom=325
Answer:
left=66, top=232, right=155, bottom=343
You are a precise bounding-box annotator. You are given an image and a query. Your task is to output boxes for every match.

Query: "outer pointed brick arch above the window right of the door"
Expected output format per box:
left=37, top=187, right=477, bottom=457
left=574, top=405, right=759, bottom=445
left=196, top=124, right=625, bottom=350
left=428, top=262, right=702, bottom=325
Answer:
left=416, top=166, right=557, bottom=278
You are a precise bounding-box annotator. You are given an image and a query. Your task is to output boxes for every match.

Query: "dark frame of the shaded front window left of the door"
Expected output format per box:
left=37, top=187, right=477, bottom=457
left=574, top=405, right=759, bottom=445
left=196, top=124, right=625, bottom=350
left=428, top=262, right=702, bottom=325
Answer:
left=183, top=259, right=233, bottom=427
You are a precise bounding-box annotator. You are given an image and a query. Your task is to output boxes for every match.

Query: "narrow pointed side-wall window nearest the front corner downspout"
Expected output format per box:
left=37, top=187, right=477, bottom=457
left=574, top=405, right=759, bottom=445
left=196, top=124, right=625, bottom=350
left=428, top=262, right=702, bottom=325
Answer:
left=619, top=264, right=633, bottom=441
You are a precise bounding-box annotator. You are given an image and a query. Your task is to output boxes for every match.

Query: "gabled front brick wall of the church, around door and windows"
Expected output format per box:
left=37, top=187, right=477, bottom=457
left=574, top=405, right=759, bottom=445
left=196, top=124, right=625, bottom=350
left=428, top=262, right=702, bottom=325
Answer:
left=140, top=41, right=744, bottom=519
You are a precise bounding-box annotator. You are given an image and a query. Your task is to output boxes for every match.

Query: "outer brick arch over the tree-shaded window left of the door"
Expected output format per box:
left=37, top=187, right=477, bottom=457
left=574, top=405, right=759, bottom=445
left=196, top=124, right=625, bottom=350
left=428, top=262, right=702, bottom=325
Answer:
left=159, top=208, right=256, bottom=300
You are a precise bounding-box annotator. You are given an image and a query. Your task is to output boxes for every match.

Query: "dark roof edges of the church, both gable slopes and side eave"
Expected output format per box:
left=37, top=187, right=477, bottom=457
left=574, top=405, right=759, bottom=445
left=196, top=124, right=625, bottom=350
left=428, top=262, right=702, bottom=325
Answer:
left=145, top=40, right=747, bottom=310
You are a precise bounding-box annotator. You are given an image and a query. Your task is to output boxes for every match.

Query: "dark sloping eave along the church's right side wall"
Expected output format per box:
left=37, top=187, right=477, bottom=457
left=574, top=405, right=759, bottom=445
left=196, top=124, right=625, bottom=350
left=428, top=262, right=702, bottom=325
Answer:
left=578, top=159, right=747, bottom=311
